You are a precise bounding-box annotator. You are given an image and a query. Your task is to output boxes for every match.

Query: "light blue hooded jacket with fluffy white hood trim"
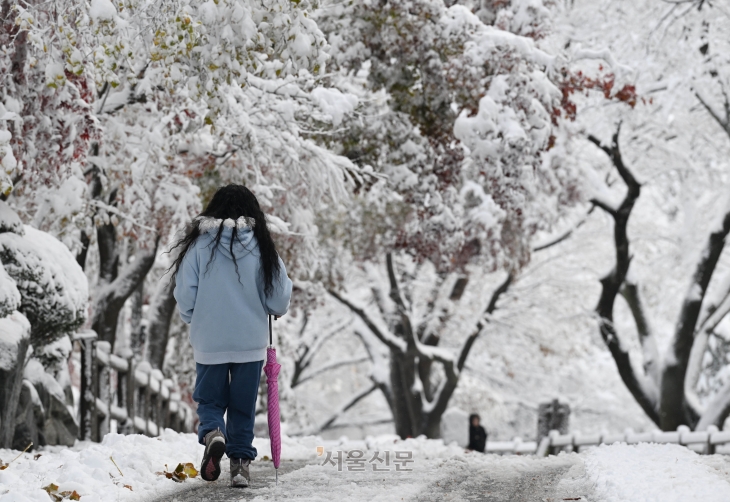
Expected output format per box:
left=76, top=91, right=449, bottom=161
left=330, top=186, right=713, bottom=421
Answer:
left=174, top=217, right=292, bottom=364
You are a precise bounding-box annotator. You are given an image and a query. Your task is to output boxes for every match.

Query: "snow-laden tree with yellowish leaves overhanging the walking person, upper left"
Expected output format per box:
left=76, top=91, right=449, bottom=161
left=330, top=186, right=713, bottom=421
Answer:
left=0, top=0, right=359, bottom=364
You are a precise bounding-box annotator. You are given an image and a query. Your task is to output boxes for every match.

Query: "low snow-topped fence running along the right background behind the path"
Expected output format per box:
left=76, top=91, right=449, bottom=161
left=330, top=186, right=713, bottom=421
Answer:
left=487, top=426, right=730, bottom=457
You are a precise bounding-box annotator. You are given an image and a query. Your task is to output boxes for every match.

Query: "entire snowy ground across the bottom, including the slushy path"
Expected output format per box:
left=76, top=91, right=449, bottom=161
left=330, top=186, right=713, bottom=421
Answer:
left=0, top=431, right=730, bottom=502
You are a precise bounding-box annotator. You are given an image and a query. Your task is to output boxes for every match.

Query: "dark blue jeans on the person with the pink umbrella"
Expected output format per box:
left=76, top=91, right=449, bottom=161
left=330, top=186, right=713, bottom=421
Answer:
left=193, top=361, right=264, bottom=460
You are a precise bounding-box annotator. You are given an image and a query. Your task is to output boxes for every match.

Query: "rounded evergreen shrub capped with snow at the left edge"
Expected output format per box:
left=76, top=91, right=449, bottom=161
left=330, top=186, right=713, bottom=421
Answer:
left=0, top=226, right=89, bottom=349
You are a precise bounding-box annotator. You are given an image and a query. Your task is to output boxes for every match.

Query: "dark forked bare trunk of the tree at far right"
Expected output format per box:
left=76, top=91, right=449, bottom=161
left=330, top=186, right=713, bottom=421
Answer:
left=589, top=124, right=730, bottom=431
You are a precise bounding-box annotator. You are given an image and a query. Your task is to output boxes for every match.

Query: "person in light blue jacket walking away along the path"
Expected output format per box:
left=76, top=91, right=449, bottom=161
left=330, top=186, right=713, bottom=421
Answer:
left=170, top=185, right=292, bottom=486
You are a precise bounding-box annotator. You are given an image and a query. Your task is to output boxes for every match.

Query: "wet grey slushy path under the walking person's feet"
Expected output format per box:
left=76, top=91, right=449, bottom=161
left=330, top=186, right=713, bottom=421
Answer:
left=162, top=457, right=589, bottom=502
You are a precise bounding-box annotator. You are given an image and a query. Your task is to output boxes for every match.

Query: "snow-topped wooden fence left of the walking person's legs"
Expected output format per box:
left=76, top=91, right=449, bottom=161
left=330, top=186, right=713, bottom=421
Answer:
left=73, top=331, right=193, bottom=442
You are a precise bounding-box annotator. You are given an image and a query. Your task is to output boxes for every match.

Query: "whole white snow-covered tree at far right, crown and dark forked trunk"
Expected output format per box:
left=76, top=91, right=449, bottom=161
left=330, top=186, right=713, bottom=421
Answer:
left=555, top=1, right=730, bottom=430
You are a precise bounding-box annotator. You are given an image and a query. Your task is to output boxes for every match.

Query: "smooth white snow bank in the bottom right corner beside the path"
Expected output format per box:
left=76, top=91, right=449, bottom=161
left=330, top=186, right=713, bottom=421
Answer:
left=584, top=444, right=730, bottom=502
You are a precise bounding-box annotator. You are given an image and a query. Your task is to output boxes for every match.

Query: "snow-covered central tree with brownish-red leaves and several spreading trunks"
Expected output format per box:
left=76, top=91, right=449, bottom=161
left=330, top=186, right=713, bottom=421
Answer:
left=295, top=1, right=620, bottom=437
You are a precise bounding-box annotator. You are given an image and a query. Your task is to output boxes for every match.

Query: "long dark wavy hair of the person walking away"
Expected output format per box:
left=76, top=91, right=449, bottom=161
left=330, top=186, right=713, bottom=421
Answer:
left=170, top=184, right=281, bottom=296
